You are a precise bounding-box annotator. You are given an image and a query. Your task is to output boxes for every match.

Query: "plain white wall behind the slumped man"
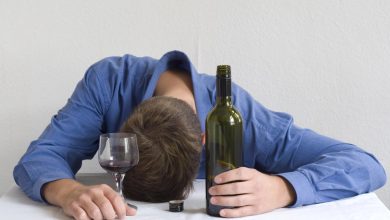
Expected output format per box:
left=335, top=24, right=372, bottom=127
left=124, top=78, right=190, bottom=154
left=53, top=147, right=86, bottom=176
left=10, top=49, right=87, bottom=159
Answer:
left=0, top=0, right=390, bottom=207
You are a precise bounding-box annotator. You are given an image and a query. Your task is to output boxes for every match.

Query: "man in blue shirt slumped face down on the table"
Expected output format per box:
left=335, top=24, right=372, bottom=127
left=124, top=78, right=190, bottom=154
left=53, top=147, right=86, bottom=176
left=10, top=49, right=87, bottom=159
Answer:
left=14, top=51, right=386, bottom=219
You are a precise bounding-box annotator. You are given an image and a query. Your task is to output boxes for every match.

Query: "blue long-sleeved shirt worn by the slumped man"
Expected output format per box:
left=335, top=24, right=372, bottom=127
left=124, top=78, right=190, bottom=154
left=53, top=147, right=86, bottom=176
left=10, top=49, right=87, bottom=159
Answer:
left=14, top=51, right=386, bottom=206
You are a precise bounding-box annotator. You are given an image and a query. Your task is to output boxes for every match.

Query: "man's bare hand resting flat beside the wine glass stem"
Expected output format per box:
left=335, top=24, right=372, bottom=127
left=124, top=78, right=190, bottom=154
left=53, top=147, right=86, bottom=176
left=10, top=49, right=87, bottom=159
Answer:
left=43, top=179, right=136, bottom=220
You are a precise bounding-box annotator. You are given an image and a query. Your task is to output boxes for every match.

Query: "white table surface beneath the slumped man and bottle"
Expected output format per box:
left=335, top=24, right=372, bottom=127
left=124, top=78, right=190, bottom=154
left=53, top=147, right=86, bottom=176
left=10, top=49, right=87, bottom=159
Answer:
left=0, top=174, right=390, bottom=220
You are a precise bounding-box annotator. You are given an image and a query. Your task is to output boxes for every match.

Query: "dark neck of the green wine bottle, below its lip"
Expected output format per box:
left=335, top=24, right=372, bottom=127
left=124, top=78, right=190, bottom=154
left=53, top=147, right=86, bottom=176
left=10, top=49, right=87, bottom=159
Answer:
left=216, top=76, right=233, bottom=106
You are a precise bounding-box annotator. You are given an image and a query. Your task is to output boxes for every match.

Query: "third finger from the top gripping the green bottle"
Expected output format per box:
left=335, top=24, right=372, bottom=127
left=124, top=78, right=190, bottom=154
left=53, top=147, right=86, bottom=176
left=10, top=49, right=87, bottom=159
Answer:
left=210, top=194, right=256, bottom=207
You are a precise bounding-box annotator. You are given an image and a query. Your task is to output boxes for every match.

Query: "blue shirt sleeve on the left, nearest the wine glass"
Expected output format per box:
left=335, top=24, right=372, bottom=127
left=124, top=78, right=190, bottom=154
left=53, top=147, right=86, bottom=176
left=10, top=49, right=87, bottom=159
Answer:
left=13, top=67, right=109, bottom=202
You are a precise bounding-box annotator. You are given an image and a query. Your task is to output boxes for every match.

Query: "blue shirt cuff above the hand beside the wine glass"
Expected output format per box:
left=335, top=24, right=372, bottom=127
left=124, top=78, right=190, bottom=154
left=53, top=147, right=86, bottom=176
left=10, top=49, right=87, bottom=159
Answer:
left=32, top=172, right=74, bottom=204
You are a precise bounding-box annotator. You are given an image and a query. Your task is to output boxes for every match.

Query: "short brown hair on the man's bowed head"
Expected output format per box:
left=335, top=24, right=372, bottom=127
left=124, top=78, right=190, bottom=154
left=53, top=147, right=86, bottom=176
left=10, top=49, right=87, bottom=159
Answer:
left=121, top=96, right=202, bottom=202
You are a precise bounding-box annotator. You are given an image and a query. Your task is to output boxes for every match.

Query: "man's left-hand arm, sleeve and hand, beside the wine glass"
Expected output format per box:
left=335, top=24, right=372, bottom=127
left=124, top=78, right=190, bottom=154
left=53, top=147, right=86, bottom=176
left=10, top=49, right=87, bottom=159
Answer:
left=14, top=57, right=139, bottom=219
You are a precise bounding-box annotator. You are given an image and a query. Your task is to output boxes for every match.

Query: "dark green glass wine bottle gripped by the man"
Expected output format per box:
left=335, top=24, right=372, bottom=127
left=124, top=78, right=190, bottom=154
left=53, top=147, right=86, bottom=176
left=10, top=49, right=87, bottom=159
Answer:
left=206, top=65, right=243, bottom=216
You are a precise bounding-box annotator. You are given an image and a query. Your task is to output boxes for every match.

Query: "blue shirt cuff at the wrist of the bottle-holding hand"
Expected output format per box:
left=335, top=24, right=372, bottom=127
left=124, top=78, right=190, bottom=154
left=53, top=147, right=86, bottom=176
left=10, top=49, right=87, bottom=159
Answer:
left=277, top=171, right=314, bottom=208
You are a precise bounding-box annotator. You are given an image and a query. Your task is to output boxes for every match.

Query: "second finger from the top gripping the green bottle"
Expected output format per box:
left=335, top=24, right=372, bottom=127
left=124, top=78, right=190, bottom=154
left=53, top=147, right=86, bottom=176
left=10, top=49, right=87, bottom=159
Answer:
left=209, top=181, right=254, bottom=196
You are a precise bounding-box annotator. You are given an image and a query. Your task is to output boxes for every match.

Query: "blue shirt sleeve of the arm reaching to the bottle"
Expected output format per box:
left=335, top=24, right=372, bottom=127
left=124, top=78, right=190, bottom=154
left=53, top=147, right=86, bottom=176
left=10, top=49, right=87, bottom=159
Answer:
left=234, top=83, right=386, bottom=207
